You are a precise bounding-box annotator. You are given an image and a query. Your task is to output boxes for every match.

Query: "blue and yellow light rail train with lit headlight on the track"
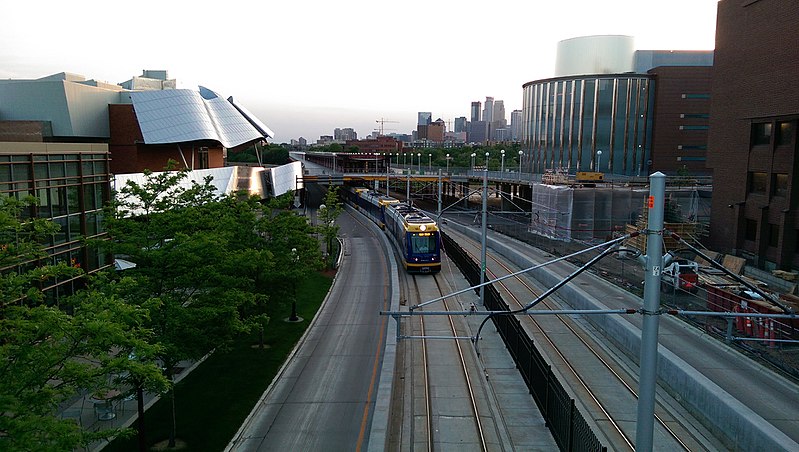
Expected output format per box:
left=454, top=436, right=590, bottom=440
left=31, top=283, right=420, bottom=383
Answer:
left=345, top=187, right=441, bottom=273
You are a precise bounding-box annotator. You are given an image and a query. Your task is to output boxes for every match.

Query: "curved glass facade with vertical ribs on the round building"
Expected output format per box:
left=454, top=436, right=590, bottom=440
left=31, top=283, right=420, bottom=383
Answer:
left=522, top=74, right=654, bottom=176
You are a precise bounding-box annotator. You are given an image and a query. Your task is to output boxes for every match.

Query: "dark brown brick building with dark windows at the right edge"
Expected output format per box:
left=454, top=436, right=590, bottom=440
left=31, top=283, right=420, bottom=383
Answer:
left=707, top=0, right=799, bottom=270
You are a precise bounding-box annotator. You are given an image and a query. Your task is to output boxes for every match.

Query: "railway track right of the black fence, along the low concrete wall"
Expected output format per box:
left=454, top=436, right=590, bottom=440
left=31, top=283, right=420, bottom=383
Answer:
left=448, top=231, right=713, bottom=451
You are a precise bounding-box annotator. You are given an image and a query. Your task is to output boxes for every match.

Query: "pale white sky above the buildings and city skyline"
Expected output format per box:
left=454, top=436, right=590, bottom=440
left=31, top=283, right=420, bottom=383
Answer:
left=0, top=0, right=718, bottom=143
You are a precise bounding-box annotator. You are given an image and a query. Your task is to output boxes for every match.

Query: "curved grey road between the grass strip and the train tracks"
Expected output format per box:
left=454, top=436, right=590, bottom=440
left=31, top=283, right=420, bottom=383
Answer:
left=228, top=212, right=396, bottom=451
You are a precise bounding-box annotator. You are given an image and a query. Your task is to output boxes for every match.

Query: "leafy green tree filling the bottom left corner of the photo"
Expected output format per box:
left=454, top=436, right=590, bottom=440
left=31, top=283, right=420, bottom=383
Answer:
left=0, top=197, right=166, bottom=450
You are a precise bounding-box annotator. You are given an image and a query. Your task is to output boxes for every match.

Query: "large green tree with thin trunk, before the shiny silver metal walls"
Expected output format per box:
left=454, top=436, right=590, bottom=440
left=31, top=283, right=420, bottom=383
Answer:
left=103, top=171, right=272, bottom=446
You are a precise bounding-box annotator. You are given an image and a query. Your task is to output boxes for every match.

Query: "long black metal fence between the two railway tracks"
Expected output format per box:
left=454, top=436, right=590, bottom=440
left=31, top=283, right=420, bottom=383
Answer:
left=441, top=233, right=607, bottom=451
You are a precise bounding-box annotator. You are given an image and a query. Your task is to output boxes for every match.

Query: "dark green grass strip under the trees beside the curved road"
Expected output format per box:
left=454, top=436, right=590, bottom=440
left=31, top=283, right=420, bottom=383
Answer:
left=104, top=273, right=332, bottom=452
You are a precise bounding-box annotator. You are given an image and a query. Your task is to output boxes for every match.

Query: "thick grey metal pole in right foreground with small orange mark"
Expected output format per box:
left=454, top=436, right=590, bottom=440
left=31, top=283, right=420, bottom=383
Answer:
left=636, top=170, right=666, bottom=452
